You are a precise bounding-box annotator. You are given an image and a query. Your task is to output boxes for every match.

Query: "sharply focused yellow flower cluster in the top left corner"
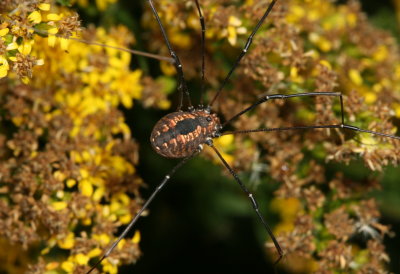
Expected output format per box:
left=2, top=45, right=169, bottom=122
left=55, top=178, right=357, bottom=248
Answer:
left=0, top=1, right=79, bottom=83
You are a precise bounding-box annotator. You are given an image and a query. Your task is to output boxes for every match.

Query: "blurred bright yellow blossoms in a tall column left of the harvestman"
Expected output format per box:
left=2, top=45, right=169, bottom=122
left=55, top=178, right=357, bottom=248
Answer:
left=33, top=28, right=142, bottom=273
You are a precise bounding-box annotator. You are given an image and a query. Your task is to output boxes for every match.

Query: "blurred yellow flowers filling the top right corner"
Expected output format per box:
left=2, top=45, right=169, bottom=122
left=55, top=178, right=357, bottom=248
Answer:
left=286, top=0, right=400, bottom=109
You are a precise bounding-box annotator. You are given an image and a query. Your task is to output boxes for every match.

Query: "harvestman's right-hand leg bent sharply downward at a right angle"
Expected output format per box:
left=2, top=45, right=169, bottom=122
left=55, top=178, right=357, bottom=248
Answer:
left=222, top=92, right=344, bottom=128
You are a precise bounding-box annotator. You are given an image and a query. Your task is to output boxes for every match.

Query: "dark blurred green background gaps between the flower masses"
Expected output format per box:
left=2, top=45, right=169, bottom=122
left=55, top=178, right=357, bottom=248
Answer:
left=79, top=0, right=400, bottom=273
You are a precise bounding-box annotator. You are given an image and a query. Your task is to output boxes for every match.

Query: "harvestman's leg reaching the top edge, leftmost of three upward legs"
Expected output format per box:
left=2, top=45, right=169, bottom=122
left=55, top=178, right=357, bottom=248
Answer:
left=147, top=0, right=193, bottom=111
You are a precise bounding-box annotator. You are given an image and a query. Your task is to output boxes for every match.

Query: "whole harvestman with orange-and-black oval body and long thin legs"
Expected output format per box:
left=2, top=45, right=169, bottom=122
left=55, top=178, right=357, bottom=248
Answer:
left=83, top=0, right=400, bottom=273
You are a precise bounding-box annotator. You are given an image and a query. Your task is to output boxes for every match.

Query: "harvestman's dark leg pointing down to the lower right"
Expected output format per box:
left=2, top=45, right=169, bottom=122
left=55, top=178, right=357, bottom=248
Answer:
left=207, top=141, right=283, bottom=265
